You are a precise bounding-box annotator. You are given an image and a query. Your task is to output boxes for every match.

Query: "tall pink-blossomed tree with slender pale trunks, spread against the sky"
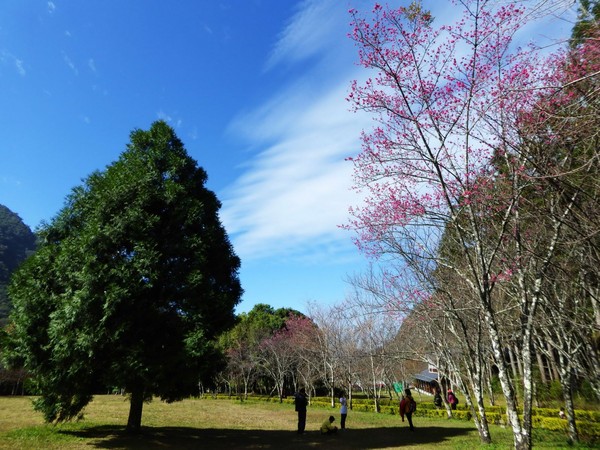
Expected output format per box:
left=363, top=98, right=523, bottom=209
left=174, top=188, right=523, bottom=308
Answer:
left=349, top=0, right=580, bottom=449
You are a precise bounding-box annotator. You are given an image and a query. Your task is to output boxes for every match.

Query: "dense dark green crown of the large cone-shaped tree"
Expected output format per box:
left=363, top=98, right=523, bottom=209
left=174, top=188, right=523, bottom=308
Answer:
left=2, top=121, right=242, bottom=425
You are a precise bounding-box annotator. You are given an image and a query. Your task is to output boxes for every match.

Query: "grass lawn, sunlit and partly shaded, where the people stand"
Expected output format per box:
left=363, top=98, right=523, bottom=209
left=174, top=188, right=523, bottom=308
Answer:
left=0, top=395, right=589, bottom=450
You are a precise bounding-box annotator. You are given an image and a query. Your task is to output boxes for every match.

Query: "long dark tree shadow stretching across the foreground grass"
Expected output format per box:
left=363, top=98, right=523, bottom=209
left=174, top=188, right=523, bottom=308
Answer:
left=61, top=426, right=470, bottom=450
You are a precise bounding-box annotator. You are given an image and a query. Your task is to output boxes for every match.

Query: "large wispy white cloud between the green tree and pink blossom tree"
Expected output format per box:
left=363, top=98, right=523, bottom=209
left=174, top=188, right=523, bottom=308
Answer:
left=221, top=0, right=365, bottom=262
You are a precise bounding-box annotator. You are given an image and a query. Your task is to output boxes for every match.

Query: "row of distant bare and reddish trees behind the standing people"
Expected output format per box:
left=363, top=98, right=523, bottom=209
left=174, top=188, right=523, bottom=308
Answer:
left=212, top=297, right=413, bottom=409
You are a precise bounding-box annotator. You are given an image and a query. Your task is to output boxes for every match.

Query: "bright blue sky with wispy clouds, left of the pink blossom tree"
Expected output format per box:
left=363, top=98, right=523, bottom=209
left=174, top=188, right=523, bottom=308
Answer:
left=0, top=0, right=570, bottom=312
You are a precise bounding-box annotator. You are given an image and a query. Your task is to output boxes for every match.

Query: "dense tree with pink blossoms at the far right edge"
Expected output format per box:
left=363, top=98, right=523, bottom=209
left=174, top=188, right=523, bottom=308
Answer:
left=510, top=31, right=600, bottom=442
